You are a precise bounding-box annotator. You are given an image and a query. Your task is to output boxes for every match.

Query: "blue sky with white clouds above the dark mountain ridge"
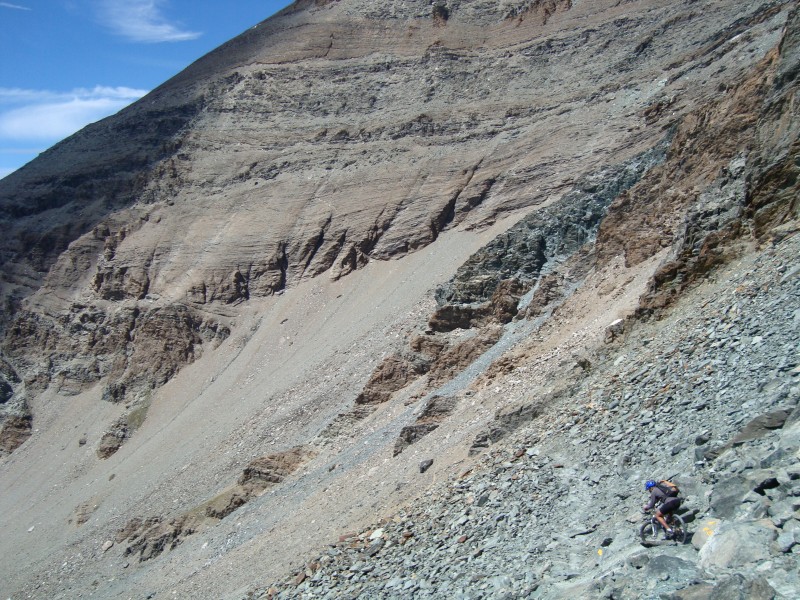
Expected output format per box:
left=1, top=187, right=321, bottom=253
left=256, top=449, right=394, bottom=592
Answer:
left=0, top=0, right=291, bottom=178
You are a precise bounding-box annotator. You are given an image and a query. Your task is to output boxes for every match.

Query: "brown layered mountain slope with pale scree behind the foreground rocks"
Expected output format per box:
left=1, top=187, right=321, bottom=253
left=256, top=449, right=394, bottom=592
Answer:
left=0, top=0, right=798, bottom=597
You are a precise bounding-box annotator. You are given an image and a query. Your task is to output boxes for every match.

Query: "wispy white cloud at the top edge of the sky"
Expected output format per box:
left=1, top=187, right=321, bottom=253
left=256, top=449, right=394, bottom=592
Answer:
left=99, top=0, right=202, bottom=43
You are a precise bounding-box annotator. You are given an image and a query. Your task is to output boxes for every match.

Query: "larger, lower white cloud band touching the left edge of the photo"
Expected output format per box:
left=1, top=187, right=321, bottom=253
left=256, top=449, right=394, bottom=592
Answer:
left=0, top=86, right=147, bottom=145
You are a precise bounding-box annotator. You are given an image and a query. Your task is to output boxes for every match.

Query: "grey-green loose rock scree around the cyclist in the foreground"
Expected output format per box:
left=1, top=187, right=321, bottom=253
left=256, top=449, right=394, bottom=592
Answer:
left=262, top=224, right=800, bottom=599
